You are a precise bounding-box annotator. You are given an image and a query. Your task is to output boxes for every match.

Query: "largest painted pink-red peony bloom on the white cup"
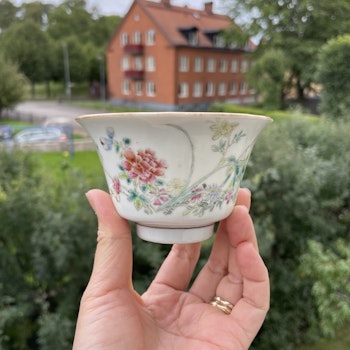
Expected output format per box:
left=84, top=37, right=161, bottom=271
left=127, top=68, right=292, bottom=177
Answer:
left=122, top=148, right=167, bottom=183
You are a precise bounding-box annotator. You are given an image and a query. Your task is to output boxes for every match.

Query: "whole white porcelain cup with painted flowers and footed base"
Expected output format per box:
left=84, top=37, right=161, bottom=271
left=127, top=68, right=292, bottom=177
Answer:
left=77, top=112, right=271, bottom=243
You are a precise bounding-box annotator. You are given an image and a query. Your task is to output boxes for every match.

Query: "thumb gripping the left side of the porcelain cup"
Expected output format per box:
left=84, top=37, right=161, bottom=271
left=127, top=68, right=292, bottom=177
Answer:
left=86, top=190, right=132, bottom=296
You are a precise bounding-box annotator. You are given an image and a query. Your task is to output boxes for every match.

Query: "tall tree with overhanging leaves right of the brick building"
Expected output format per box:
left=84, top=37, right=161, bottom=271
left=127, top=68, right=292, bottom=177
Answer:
left=225, top=0, right=350, bottom=103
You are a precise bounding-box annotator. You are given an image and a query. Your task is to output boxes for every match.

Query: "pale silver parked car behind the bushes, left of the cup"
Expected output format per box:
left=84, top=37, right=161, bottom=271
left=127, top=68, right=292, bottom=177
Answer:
left=13, top=127, right=68, bottom=144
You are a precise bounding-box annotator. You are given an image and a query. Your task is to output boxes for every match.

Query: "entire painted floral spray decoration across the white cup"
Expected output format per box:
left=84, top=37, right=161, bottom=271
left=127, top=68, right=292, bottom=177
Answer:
left=99, top=119, right=251, bottom=217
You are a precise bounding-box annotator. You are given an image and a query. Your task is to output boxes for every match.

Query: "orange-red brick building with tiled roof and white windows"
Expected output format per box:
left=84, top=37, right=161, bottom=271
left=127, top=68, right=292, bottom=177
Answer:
left=107, top=0, right=253, bottom=110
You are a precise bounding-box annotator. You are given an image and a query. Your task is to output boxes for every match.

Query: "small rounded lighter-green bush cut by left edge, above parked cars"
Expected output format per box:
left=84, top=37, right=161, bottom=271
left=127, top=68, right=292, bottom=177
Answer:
left=0, top=55, right=27, bottom=118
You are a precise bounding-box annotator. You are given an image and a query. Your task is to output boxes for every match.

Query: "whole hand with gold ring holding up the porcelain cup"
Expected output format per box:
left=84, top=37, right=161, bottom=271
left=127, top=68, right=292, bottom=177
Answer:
left=73, top=189, right=270, bottom=350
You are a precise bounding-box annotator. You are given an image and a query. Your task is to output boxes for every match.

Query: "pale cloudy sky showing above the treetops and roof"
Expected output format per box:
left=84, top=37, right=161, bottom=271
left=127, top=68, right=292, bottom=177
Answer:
left=12, top=0, right=222, bottom=16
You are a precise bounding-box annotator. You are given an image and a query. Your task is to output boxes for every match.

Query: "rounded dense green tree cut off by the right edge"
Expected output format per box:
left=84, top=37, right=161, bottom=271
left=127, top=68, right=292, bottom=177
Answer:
left=316, top=34, right=350, bottom=118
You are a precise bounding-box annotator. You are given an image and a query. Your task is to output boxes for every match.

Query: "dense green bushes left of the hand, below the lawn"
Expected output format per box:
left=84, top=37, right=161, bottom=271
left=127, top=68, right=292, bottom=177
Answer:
left=0, top=153, right=96, bottom=350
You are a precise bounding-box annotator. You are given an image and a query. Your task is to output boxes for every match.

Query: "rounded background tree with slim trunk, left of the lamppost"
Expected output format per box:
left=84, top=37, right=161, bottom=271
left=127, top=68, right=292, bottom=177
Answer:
left=0, top=20, right=53, bottom=97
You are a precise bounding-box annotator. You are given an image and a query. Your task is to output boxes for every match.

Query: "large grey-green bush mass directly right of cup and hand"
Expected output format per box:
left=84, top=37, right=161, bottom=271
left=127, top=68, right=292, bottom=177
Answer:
left=245, top=118, right=350, bottom=349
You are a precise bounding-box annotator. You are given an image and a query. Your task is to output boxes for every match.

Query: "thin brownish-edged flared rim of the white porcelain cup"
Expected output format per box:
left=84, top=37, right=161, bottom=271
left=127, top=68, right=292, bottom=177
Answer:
left=75, top=111, right=273, bottom=122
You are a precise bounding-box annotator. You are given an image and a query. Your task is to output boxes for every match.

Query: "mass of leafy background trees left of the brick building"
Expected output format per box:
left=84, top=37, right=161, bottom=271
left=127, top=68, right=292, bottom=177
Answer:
left=0, top=0, right=121, bottom=95
